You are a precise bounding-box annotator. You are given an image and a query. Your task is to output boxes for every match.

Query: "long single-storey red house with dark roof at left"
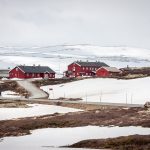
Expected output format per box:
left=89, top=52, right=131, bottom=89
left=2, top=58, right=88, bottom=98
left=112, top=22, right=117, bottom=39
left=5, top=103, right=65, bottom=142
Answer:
left=9, top=65, right=55, bottom=79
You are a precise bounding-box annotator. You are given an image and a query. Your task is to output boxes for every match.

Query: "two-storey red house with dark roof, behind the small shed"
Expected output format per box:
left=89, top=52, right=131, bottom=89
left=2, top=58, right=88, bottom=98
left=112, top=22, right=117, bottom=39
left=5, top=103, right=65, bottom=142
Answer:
left=65, top=61, right=108, bottom=77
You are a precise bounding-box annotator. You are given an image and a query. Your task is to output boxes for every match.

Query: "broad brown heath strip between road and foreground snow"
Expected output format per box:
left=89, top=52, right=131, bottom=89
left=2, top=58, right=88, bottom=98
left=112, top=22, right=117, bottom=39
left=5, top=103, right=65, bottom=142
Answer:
left=0, top=101, right=150, bottom=137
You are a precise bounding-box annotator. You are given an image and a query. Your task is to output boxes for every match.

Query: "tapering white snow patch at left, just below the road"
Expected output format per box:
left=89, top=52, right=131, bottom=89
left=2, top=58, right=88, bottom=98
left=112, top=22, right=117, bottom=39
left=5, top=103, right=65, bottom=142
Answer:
left=0, top=104, right=82, bottom=120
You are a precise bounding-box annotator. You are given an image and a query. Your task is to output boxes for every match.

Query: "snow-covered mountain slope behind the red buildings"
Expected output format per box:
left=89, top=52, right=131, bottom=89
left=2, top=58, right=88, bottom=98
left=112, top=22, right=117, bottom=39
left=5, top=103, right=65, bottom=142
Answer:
left=0, top=45, right=150, bottom=73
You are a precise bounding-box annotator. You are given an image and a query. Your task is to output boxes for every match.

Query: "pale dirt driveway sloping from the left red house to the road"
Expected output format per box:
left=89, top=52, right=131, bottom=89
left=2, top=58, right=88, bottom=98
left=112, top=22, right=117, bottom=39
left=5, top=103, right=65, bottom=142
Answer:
left=17, top=80, right=48, bottom=99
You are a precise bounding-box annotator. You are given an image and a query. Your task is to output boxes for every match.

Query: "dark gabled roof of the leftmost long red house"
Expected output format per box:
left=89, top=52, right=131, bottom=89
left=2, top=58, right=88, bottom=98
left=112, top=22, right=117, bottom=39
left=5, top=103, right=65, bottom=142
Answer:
left=17, top=66, right=55, bottom=73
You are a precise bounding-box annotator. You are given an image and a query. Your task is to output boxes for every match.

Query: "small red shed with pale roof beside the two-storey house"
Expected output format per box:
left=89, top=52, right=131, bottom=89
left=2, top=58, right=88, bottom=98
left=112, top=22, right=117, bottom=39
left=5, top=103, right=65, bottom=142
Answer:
left=96, top=67, right=121, bottom=77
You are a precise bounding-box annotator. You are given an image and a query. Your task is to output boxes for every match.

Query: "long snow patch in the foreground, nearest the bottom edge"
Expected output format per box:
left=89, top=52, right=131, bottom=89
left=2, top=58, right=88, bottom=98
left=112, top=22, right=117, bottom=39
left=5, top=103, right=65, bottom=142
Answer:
left=0, top=126, right=150, bottom=150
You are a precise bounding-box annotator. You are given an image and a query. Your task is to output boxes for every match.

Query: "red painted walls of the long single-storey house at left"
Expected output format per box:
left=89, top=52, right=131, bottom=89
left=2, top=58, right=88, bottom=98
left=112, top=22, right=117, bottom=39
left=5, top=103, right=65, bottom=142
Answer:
left=9, top=67, right=55, bottom=79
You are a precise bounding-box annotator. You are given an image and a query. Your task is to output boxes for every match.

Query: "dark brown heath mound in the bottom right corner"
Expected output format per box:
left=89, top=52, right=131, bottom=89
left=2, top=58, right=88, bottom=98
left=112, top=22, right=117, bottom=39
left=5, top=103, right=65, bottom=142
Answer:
left=68, top=135, right=150, bottom=150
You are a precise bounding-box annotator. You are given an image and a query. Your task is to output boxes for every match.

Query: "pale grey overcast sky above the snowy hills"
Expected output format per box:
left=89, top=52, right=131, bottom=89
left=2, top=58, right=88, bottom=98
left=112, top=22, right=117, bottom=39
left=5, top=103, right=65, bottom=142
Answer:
left=0, top=0, right=150, bottom=49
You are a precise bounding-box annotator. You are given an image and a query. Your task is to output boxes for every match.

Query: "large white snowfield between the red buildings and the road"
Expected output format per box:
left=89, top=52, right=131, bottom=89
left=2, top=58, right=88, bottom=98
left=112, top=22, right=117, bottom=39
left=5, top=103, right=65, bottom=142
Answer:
left=41, top=77, right=150, bottom=104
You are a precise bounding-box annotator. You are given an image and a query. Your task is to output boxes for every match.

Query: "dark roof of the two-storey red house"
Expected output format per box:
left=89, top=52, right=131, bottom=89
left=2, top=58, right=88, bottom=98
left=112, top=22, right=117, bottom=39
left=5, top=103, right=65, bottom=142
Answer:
left=74, top=61, right=109, bottom=67
